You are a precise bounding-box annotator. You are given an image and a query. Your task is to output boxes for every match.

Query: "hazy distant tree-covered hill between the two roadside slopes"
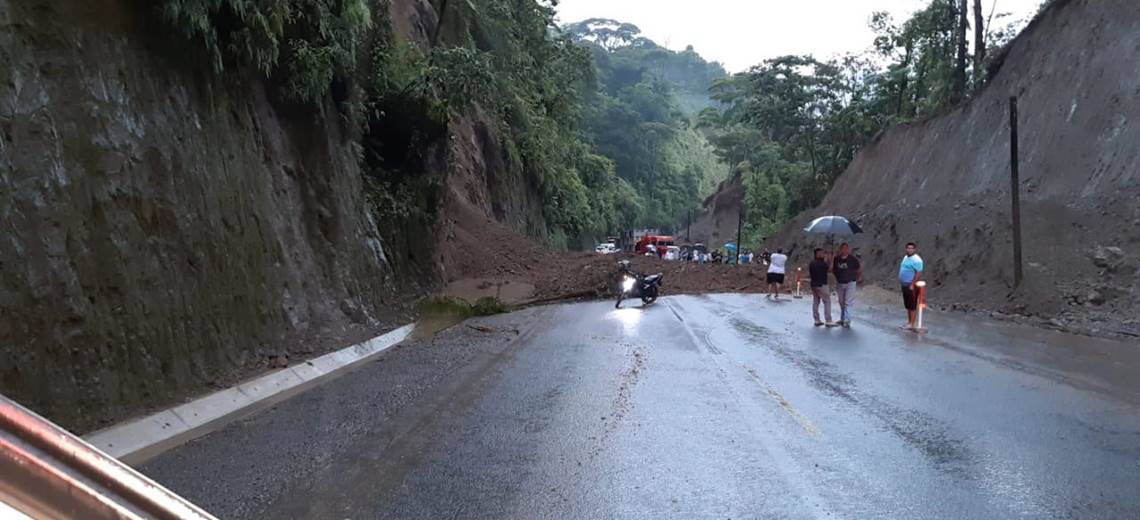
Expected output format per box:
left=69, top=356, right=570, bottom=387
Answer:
left=563, top=18, right=727, bottom=229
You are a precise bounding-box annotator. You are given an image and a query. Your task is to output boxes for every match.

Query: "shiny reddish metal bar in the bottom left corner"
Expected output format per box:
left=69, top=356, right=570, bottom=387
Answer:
left=0, top=396, right=214, bottom=520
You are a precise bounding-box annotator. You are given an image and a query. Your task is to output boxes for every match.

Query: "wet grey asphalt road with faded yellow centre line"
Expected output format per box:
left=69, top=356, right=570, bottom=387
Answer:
left=143, top=295, right=1140, bottom=519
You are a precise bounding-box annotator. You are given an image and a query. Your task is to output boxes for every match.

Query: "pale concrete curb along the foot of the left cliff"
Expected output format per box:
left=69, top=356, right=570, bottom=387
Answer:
left=83, top=324, right=415, bottom=464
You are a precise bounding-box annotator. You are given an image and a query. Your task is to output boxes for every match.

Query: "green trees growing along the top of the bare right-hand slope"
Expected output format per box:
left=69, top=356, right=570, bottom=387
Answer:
left=699, top=0, right=1044, bottom=243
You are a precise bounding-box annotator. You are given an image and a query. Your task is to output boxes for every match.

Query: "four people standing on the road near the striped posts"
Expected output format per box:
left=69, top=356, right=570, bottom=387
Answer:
left=767, top=242, right=923, bottom=331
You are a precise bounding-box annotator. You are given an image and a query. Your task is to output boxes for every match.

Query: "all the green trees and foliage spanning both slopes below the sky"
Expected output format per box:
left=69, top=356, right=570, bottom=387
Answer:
left=160, top=0, right=1044, bottom=246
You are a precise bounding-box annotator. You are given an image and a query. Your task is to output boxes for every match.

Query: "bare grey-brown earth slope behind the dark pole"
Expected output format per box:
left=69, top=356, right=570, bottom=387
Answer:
left=771, top=0, right=1140, bottom=333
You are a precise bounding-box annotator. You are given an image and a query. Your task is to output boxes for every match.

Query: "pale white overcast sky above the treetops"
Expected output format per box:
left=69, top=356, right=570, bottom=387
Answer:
left=559, top=0, right=1041, bottom=72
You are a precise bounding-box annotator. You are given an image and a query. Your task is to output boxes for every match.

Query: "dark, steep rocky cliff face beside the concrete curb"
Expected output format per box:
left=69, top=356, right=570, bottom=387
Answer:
left=0, top=0, right=544, bottom=429
